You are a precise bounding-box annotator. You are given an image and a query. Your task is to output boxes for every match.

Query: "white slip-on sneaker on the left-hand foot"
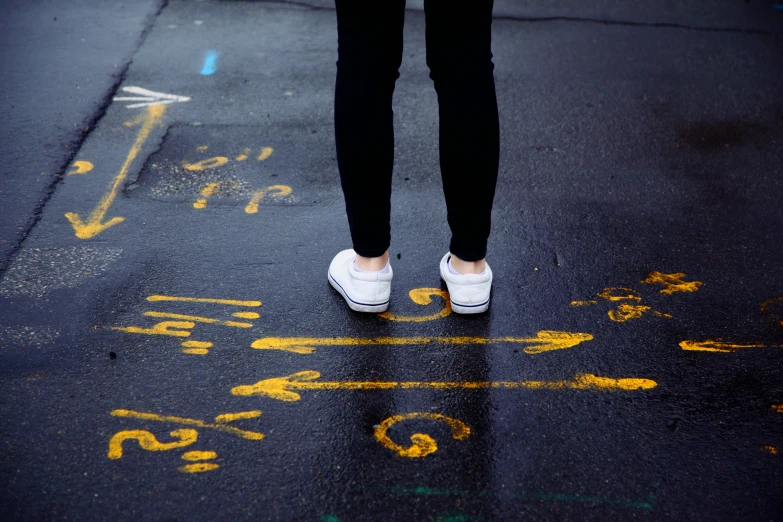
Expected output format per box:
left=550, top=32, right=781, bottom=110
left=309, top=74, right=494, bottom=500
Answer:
left=329, top=249, right=393, bottom=313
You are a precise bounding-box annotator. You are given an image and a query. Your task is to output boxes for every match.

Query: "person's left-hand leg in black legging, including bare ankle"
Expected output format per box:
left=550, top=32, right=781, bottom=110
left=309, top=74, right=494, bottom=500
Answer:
left=334, top=0, right=405, bottom=270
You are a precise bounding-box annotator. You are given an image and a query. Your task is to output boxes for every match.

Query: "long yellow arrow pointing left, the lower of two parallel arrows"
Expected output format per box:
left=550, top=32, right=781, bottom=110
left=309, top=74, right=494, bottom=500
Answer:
left=231, top=370, right=658, bottom=402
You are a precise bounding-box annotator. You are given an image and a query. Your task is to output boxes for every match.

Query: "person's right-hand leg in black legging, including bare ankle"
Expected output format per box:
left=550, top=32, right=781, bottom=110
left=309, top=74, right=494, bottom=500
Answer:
left=424, top=0, right=500, bottom=273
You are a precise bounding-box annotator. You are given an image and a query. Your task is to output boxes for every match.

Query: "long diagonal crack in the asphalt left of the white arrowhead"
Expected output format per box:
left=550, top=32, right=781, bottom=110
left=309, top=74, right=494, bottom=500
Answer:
left=0, top=0, right=169, bottom=281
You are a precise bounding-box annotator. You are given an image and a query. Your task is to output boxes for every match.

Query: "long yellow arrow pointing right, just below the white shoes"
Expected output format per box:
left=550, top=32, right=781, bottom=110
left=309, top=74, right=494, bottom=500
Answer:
left=251, top=330, right=593, bottom=355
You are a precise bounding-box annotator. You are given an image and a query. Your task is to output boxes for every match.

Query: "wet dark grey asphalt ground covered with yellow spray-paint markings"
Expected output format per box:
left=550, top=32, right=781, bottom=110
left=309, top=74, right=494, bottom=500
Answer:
left=0, top=0, right=783, bottom=522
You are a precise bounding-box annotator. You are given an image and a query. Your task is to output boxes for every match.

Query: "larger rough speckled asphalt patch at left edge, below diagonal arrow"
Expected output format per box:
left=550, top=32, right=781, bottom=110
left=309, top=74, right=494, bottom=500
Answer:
left=0, top=246, right=122, bottom=298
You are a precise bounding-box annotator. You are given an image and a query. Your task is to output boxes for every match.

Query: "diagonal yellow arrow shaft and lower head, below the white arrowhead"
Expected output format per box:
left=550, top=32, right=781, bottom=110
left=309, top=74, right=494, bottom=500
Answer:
left=65, top=105, right=166, bottom=239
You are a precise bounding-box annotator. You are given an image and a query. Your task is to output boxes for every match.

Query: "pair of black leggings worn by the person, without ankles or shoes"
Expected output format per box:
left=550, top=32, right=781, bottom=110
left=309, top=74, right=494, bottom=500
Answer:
left=334, top=0, right=500, bottom=261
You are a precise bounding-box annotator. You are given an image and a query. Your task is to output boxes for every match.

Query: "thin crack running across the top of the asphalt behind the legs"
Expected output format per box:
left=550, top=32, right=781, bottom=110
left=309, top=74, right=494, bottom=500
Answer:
left=250, top=0, right=783, bottom=36
